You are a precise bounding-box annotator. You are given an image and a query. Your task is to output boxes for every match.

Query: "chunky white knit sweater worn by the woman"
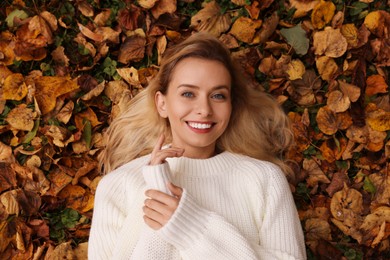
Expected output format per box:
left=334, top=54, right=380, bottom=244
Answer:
left=88, top=152, right=306, bottom=260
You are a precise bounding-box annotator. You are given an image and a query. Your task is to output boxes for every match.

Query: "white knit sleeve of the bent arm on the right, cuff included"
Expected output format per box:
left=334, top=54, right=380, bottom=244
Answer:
left=154, top=165, right=305, bottom=260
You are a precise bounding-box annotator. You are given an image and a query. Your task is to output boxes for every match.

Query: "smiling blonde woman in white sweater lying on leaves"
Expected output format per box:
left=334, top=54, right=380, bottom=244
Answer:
left=89, top=33, right=306, bottom=259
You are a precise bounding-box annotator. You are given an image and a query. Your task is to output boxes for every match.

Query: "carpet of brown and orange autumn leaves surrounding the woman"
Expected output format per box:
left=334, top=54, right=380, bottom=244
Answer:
left=0, top=0, right=390, bottom=259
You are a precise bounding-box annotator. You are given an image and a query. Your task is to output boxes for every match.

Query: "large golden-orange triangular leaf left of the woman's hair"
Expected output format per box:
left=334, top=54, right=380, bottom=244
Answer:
left=35, top=76, right=79, bottom=115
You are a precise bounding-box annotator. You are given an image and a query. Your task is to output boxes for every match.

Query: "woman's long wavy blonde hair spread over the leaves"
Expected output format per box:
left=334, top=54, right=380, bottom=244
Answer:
left=99, top=33, right=293, bottom=177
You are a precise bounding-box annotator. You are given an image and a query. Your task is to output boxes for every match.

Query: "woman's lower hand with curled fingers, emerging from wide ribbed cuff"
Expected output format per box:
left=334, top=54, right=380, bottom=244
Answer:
left=142, top=182, right=183, bottom=230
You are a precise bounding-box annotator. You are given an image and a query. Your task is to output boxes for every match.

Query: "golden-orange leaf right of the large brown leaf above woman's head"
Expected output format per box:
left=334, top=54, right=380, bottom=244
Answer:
left=230, top=16, right=262, bottom=43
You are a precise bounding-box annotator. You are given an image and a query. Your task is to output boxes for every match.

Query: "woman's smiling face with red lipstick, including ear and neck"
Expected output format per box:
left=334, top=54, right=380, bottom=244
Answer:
left=155, top=57, right=232, bottom=158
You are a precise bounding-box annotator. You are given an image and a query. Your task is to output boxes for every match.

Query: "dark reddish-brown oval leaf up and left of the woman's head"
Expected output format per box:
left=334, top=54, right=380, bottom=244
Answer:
left=118, top=35, right=146, bottom=64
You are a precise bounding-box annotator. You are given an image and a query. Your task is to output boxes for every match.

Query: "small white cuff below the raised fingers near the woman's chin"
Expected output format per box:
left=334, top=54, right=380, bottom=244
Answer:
left=142, top=162, right=171, bottom=195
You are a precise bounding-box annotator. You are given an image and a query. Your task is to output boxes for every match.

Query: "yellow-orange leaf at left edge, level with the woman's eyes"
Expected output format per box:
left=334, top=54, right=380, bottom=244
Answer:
left=2, top=73, right=28, bottom=101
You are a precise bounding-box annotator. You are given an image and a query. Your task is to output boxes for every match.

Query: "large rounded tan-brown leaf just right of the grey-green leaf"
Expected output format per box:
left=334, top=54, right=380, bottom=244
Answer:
left=313, top=27, right=348, bottom=58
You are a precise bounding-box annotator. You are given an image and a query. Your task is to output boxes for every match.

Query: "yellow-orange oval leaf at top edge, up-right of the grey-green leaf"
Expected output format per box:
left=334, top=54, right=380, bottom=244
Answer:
left=311, top=1, right=336, bottom=29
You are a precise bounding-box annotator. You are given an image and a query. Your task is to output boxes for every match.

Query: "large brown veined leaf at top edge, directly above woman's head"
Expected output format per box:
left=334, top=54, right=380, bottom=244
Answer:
left=191, top=1, right=231, bottom=37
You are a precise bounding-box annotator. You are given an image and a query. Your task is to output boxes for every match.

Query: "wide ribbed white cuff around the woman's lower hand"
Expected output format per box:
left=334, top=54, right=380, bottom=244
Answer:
left=157, top=189, right=210, bottom=250
